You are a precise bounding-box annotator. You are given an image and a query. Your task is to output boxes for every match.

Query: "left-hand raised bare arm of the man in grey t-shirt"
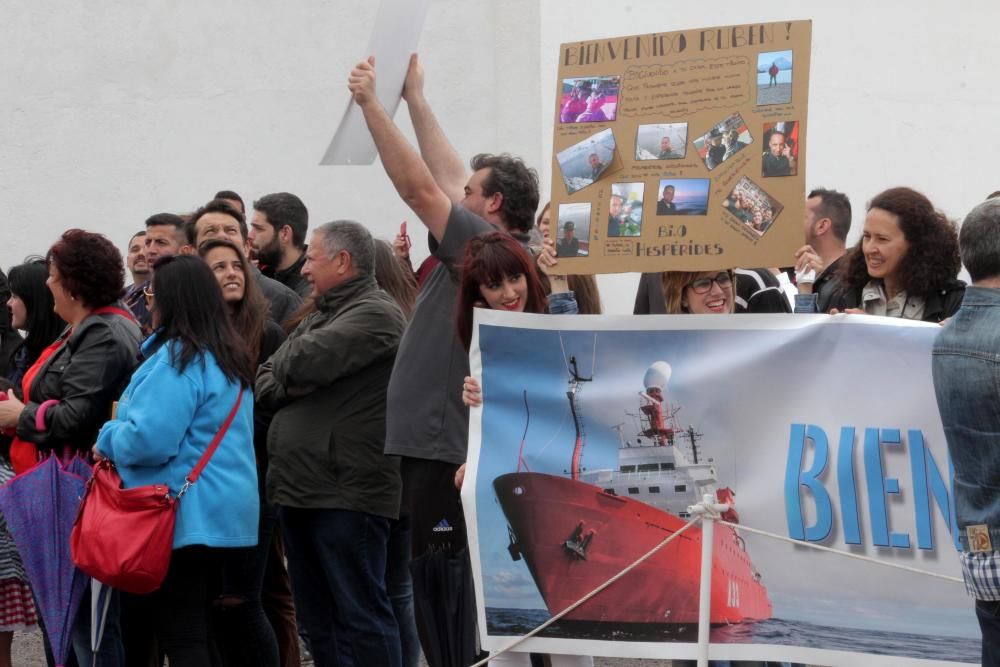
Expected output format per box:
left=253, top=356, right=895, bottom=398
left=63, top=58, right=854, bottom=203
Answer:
left=347, top=57, right=451, bottom=241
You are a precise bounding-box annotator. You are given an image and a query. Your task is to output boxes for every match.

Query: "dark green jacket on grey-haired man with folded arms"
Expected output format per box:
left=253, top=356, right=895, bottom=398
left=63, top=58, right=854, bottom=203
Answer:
left=256, top=277, right=406, bottom=518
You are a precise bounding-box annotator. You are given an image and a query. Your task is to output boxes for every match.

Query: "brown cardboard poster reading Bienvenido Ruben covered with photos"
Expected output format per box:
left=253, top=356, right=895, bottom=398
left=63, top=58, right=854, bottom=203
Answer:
left=552, top=21, right=812, bottom=274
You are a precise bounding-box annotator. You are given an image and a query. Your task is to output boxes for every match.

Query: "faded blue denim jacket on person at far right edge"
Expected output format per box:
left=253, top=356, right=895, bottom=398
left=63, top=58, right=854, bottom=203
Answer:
left=931, top=287, right=1000, bottom=550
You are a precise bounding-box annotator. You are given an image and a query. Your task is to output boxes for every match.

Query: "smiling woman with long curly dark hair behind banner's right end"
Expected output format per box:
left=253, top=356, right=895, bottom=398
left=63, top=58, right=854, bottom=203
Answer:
left=831, top=188, right=965, bottom=322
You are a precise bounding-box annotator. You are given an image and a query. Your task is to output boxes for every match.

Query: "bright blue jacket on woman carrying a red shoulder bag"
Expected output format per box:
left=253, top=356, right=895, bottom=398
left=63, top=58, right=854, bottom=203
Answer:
left=96, top=334, right=260, bottom=549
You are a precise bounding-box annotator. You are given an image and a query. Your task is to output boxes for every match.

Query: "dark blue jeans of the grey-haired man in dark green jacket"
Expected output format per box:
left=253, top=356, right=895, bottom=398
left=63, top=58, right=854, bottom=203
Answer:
left=280, top=507, right=401, bottom=667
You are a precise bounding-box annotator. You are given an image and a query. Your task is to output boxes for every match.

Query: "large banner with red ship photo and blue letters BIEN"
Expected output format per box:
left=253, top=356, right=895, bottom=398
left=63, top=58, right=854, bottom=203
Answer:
left=462, top=310, right=980, bottom=666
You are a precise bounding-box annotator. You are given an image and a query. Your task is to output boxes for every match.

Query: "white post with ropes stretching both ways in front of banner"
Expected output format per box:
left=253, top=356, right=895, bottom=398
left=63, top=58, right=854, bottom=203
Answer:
left=470, top=494, right=964, bottom=667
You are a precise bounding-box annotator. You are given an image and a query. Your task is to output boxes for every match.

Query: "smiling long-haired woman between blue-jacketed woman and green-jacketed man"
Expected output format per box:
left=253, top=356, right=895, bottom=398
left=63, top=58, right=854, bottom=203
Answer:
left=198, top=238, right=285, bottom=667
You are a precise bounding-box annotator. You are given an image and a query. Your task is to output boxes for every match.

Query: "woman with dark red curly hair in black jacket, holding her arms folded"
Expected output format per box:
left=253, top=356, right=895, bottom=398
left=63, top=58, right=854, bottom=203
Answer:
left=0, top=229, right=141, bottom=667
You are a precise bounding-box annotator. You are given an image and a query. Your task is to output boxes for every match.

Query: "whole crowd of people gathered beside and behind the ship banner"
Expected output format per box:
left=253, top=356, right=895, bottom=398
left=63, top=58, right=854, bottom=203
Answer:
left=0, top=51, right=1000, bottom=667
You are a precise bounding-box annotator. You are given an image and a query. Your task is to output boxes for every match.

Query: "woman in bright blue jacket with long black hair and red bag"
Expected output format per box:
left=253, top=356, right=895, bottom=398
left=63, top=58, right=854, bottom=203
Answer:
left=95, top=255, right=259, bottom=667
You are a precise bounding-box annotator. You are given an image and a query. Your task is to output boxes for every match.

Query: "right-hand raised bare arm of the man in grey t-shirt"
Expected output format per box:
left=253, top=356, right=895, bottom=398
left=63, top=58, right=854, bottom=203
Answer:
left=403, top=53, right=468, bottom=202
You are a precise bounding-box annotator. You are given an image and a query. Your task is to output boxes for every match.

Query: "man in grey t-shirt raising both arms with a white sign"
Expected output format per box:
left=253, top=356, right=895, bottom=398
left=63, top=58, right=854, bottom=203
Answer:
left=348, top=55, right=538, bottom=652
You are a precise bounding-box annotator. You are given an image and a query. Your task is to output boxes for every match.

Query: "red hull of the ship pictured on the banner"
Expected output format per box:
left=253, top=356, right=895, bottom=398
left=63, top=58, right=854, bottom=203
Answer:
left=493, top=472, right=772, bottom=624
